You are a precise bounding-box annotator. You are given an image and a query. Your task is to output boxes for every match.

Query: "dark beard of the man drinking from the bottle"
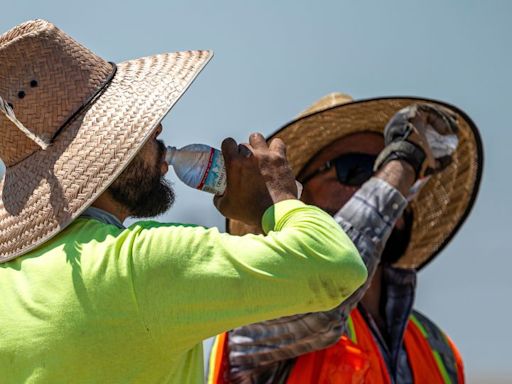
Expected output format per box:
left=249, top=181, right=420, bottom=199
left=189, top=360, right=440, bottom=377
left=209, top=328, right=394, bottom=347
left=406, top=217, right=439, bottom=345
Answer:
left=109, top=140, right=175, bottom=218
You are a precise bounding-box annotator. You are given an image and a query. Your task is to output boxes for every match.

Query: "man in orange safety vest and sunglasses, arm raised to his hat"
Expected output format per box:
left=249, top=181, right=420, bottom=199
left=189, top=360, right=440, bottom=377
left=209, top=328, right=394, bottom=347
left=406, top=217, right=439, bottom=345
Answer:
left=210, top=94, right=482, bottom=384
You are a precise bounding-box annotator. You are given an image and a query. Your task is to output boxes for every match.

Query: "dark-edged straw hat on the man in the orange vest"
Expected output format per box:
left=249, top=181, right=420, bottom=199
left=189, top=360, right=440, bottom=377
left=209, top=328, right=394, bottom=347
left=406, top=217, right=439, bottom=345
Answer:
left=227, top=93, right=483, bottom=270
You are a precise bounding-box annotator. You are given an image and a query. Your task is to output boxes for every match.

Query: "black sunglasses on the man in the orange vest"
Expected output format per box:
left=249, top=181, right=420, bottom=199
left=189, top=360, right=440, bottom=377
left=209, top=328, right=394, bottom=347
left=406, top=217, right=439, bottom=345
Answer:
left=302, top=153, right=377, bottom=186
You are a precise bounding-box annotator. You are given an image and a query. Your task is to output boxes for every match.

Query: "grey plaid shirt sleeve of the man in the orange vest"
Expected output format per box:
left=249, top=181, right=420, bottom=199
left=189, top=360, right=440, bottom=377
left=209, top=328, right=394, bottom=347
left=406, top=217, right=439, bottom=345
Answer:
left=228, top=178, right=407, bottom=382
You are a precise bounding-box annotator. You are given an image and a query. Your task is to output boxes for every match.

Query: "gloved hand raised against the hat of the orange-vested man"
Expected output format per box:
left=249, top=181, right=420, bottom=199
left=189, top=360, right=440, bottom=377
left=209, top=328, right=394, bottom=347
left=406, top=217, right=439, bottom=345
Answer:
left=375, top=104, right=458, bottom=178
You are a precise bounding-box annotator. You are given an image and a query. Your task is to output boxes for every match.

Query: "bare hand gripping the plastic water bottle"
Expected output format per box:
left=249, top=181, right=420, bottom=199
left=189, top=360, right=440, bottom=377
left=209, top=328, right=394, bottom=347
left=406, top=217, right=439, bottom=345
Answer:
left=214, top=133, right=297, bottom=226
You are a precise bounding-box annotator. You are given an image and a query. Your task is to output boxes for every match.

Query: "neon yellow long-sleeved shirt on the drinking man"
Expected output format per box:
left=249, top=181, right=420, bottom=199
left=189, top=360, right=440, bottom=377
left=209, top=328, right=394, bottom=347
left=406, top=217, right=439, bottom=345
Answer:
left=0, top=200, right=366, bottom=384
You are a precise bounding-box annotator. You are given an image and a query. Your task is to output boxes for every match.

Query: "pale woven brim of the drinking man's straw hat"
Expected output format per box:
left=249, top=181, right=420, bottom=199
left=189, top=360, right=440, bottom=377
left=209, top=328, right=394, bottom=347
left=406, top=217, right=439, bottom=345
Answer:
left=0, top=51, right=213, bottom=262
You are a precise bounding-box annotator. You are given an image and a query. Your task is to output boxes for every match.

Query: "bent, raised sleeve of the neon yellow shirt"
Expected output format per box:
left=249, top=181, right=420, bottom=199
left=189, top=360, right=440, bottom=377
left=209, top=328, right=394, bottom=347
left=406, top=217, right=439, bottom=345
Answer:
left=120, top=200, right=367, bottom=352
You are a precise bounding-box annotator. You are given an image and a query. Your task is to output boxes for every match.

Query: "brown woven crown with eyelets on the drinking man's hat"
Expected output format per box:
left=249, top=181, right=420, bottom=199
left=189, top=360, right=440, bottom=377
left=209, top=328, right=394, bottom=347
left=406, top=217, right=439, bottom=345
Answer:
left=0, top=20, right=112, bottom=167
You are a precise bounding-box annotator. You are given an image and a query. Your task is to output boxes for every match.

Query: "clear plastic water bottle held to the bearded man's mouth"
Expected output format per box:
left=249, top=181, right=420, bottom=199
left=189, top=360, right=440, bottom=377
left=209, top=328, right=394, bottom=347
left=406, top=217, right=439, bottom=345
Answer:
left=165, top=144, right=226, bottom=195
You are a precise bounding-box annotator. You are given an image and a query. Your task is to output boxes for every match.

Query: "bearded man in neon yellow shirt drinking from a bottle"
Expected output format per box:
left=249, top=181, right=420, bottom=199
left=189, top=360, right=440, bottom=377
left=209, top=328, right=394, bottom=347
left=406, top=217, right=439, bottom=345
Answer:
left=0, top=20, right=366, bottom=384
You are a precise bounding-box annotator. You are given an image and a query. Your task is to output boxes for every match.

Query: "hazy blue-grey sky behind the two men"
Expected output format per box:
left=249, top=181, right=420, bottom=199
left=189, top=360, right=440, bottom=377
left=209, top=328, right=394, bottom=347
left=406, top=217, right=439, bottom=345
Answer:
left=0, top=0, right=512, bottom=382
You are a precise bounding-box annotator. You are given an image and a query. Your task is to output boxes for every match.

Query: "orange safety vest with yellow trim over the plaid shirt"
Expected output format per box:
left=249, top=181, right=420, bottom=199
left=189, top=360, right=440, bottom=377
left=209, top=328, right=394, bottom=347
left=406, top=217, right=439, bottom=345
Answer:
left=208, top=309, right=464, bottom=384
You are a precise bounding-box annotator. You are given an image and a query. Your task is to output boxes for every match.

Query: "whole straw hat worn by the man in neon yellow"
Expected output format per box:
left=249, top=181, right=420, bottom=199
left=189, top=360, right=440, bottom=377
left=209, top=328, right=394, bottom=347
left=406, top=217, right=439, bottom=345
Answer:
left=0, top=20, right=212, bottom=262
